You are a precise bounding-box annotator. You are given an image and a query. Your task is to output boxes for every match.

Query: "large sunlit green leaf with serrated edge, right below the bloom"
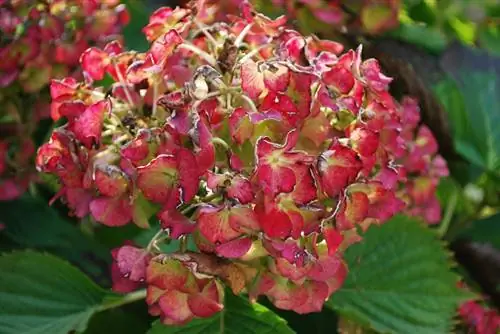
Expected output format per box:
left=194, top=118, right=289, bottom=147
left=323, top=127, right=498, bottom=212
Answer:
left=327, top=216, right=466, bottom=334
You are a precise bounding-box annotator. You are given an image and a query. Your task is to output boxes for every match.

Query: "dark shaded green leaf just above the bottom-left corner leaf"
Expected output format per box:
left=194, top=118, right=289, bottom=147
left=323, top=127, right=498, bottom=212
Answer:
left=0, top=195, right=111, bottom=281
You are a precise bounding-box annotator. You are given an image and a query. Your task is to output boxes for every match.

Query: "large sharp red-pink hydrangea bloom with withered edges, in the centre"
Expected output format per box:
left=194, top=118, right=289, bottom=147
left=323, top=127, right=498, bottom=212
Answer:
left=37, top=2, right=446, bottom=324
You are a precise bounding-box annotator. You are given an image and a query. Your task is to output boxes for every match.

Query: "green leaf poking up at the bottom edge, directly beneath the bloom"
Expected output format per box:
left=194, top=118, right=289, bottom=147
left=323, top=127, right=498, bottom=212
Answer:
left=148, top=292, right=293, bottom=334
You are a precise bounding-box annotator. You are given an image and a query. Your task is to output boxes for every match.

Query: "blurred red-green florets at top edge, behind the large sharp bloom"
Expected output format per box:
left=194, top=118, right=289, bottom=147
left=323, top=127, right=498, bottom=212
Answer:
left=184, top=0, right=401, bottom=35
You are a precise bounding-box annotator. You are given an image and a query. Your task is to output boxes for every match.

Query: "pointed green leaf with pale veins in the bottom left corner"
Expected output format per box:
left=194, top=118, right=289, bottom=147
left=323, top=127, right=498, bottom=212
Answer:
left=0, top=251, right=108, bottom=334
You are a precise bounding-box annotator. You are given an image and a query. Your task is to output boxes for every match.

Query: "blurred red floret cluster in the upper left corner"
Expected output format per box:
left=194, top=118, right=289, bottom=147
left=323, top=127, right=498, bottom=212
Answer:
left=0, top=0, right=128, bottom=200
